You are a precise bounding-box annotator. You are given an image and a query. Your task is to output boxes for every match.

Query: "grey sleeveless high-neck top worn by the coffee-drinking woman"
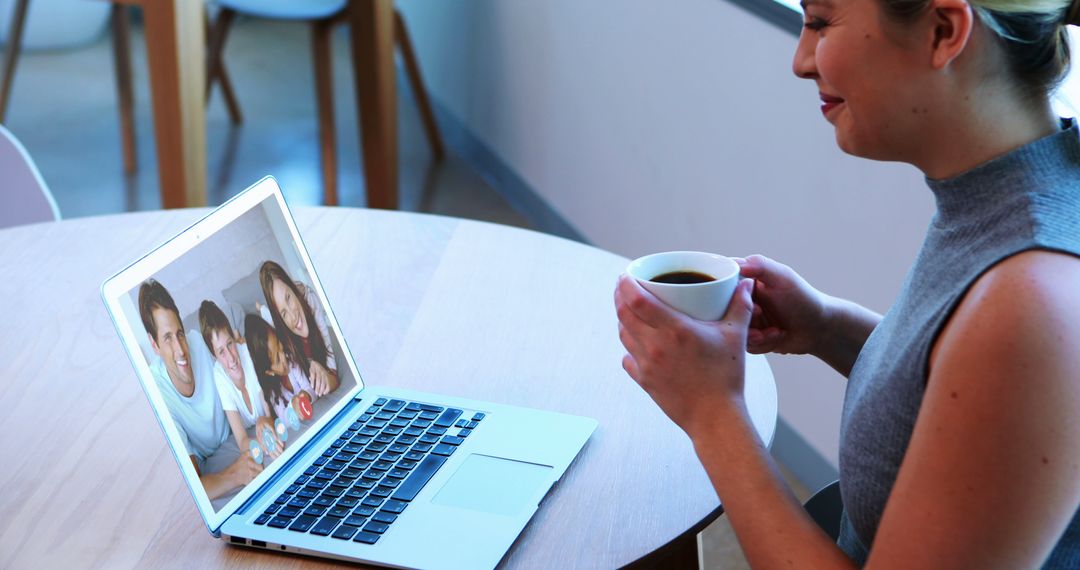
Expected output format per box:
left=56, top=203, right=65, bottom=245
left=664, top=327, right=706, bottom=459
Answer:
left=838, top=120, right=1080, bottom=568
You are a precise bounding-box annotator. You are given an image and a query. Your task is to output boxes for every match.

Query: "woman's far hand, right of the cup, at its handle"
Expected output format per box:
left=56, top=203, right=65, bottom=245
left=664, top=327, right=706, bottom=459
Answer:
left=734, top=255, right=828, bottom=354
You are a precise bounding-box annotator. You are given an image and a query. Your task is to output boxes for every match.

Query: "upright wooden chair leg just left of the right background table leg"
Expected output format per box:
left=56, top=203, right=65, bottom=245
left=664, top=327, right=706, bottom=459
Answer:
left=311, top=19, right=338, bottom=206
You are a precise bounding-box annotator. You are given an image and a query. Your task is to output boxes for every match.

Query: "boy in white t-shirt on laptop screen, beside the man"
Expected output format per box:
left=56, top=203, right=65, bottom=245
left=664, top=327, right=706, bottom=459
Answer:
left=199, top=300, right=282, bottom=462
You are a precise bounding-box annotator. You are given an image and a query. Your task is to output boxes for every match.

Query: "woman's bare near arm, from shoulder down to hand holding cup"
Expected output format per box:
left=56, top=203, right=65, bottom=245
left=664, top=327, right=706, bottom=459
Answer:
left=616, top=253, right=1080, bottom=568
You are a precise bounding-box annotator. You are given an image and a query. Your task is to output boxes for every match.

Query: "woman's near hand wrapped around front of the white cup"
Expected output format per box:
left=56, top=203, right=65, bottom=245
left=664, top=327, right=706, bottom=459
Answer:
left=615, top=275, right=753, bottom=439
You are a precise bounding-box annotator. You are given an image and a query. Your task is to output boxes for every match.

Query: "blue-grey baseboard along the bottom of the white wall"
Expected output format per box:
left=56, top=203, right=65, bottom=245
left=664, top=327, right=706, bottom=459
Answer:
left=432, top=98, right=838, bottom=491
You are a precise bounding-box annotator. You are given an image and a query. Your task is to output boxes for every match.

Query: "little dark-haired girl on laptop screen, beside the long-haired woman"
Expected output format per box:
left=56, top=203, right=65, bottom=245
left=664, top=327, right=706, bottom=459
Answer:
left=244, top=314, right=322, bottom=421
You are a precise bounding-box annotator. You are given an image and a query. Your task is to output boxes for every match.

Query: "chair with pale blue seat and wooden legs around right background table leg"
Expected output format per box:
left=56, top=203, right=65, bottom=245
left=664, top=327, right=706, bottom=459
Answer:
left=206, top=0, right=445, bottom=205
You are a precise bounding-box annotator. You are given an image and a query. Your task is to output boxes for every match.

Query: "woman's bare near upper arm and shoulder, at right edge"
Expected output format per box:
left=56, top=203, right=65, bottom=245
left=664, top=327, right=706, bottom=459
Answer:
left=869, top=252, right=1080, bottom=568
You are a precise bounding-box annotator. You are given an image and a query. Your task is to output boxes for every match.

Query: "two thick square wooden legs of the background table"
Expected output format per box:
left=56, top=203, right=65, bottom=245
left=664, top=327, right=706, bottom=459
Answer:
left=89, top=0, right=397, bottom=209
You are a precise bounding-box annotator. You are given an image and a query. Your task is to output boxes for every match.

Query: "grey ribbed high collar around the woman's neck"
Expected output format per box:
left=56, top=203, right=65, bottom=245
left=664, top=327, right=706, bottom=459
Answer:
left=927, top=119, right=1080, bottom=226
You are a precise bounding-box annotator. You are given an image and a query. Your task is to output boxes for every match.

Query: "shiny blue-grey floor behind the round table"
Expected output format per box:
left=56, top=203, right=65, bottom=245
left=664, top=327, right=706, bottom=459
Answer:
left=6, top=16, right=807, bottom=568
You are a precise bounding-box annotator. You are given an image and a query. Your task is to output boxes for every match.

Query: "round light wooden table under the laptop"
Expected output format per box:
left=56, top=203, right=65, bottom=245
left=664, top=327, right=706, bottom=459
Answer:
left=0, top=208, right=777, bottom=569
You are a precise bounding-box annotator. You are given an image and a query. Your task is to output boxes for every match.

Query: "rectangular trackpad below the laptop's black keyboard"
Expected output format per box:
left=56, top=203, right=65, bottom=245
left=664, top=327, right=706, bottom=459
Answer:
left=431, top=453, right=552, bottom=516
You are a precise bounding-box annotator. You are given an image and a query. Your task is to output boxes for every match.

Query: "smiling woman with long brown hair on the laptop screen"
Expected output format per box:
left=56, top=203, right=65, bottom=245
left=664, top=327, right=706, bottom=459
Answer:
left=259, top=261, right=338, bottom=396
